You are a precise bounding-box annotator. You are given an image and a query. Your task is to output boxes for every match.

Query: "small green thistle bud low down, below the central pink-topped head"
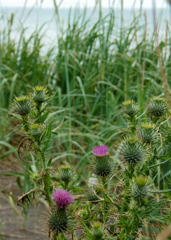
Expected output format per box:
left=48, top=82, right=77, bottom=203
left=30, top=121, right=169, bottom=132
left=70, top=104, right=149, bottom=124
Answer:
left=86, top=185, right=104, bottom=204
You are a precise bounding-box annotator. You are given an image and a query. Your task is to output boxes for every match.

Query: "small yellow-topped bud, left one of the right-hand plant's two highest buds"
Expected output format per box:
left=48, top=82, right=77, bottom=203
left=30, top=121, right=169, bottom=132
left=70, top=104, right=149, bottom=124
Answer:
left=122, top=100, right=139, bottom=117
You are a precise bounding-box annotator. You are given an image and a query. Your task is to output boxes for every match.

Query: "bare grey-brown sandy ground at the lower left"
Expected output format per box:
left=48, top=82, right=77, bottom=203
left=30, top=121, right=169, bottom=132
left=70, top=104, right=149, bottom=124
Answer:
left=0, top=160, right=48, bottom=240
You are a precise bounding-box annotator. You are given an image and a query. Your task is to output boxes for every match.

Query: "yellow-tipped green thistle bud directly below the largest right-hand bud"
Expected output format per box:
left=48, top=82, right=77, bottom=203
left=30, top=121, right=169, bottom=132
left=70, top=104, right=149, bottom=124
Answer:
left=131, top=176, right=151, bottom=199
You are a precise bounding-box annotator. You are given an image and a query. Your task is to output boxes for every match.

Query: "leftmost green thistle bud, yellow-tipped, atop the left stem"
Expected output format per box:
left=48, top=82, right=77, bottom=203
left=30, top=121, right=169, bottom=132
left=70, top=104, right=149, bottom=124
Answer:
left=13, top=96, right=32, bottom=116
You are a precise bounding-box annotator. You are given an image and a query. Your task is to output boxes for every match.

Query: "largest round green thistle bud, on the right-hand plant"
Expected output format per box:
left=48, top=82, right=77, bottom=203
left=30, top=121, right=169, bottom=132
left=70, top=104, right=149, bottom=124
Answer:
left=119, top=137, right=146, bottom=164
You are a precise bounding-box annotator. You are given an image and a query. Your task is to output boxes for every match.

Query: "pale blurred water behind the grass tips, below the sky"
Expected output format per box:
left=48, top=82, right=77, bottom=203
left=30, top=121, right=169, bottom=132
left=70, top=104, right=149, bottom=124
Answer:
left=0, top=7, right=170, bottom=49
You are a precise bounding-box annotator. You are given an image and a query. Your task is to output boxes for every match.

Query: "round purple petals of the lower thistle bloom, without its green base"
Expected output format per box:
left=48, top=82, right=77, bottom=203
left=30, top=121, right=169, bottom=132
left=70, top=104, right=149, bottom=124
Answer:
left=53, top=189, right=73, bottom=208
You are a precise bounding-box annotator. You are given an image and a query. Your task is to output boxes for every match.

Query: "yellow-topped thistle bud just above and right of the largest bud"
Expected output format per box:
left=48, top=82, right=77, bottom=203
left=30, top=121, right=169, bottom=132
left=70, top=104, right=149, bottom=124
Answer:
left=137, top=123, right=157, bottom=144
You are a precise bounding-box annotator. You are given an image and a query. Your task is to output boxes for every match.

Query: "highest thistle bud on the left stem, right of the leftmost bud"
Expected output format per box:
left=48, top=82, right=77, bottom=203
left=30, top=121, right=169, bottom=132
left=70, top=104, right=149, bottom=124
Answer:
left=31, top=86, right=47, bottom=104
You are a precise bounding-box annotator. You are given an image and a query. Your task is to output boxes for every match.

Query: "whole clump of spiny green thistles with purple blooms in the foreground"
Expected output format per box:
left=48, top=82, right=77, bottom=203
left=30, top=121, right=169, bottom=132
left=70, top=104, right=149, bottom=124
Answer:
left=9, top=91, right=171, bottom=240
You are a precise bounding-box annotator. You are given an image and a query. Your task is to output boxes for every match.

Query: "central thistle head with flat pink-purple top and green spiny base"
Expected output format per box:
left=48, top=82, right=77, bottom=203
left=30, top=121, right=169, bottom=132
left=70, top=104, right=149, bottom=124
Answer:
left=92, top=145, right=113, bottom=177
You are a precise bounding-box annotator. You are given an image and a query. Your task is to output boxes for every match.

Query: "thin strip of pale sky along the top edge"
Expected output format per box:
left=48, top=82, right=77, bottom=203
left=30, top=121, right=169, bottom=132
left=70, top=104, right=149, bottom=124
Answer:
left=0, top=0, right=168, bottom=8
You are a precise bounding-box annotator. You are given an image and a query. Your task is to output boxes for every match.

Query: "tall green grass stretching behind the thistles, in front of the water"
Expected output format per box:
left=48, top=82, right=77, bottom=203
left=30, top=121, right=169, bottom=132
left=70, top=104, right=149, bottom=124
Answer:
left=0, top=1, right=171, bottom=179
